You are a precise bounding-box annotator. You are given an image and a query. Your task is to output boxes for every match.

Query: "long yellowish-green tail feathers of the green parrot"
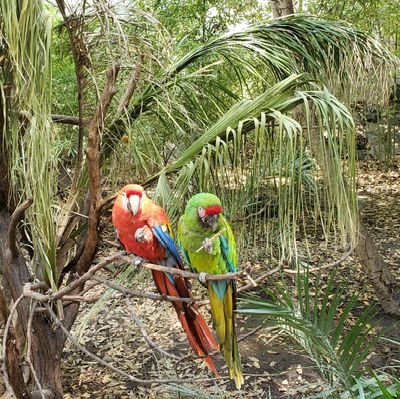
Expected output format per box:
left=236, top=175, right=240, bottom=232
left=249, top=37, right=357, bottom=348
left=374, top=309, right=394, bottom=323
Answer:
left=208, top=282, right=244, bottom=389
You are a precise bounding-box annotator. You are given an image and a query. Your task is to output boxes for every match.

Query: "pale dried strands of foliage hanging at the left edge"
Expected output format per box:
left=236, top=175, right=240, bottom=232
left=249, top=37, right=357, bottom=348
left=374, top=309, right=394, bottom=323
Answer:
left=0, top=0, right=56, bottom=284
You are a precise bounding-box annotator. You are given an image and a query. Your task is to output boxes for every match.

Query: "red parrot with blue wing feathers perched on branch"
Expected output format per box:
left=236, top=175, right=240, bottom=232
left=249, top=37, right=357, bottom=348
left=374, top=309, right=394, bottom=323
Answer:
left=112, top=184, right=219, bottom=377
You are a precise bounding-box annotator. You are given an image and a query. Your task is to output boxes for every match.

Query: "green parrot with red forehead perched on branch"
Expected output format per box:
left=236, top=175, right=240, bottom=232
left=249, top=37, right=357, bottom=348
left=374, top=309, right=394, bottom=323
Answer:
left=178, top=193, right=244, bottom=389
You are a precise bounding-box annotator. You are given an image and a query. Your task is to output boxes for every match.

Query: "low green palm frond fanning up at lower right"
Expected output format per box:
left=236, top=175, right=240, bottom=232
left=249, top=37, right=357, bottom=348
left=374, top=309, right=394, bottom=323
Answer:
left=239, top=271, right=377, bottom=397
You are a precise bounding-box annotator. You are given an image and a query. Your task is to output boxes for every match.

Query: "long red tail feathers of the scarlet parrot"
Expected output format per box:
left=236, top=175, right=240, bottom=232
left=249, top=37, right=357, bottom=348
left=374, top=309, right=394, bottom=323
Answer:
left=152, top=270, right=219, bottom=377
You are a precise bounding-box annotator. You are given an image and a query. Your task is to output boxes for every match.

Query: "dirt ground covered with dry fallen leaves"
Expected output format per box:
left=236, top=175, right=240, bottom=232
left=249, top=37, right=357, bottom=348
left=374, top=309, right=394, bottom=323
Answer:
left=59, top=161, right=400, bottom=399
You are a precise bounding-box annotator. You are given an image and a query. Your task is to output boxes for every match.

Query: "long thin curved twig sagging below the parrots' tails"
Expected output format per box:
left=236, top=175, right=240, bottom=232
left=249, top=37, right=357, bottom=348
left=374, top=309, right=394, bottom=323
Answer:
left=46, top=305, right=222, bottom=385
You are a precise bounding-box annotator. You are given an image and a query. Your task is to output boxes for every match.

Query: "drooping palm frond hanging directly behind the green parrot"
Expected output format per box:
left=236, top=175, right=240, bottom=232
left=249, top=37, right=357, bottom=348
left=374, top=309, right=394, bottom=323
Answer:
left=150, top=75, right=357, bottom=259
